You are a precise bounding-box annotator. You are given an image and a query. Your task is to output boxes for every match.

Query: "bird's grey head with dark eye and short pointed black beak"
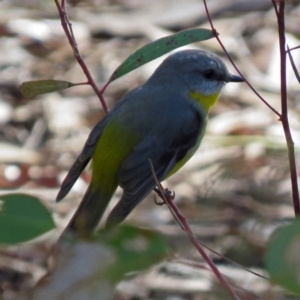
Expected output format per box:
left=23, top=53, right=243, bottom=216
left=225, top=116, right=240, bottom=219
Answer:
left=148, top=49, right=244, bottom=95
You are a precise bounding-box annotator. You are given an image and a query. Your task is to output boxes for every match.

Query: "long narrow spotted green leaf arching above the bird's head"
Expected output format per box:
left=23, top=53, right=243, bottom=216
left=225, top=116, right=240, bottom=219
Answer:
left=108, top=28, right=214, bottom=82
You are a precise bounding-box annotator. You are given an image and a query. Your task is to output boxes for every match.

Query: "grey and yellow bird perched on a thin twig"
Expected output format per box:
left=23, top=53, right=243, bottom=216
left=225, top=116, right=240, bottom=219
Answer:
left=57, top=49, right=244, bottom=237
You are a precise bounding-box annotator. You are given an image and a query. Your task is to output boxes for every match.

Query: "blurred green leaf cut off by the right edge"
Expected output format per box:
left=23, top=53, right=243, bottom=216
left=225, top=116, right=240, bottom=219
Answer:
left=265, top=219, right=300, bottom=295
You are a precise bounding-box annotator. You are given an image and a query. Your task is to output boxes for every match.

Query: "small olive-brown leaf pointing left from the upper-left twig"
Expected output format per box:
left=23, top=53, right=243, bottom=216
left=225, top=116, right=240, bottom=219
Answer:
left=19, top=80, right=76, bottom=98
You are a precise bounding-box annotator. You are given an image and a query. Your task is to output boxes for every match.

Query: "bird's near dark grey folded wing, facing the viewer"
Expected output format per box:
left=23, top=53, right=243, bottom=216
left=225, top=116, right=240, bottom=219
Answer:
left=106, top=109, right=203, bottom=227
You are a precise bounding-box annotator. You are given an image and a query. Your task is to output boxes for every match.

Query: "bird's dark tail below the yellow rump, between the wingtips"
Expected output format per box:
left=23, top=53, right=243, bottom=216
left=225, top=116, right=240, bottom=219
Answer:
left=62, top=185, right=113, bottom=237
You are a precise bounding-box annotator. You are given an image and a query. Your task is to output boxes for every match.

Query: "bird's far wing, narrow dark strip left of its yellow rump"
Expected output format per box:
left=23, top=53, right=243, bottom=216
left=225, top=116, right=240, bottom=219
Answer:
left=56, top=118, right=106, bottom=202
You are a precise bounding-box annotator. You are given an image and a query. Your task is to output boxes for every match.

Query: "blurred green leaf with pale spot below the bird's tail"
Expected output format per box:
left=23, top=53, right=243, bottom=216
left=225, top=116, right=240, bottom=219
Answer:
left=96, top=226, right=168, bottom=282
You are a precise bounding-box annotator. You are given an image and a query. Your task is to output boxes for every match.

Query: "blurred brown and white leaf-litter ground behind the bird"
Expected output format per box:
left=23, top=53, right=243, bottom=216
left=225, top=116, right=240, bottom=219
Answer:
left=0, top=0, right=300, bottom=300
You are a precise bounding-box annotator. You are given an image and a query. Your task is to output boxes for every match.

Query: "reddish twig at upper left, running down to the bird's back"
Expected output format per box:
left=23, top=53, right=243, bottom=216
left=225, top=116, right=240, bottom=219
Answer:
left=54, top=0, right=108, bottom=113
